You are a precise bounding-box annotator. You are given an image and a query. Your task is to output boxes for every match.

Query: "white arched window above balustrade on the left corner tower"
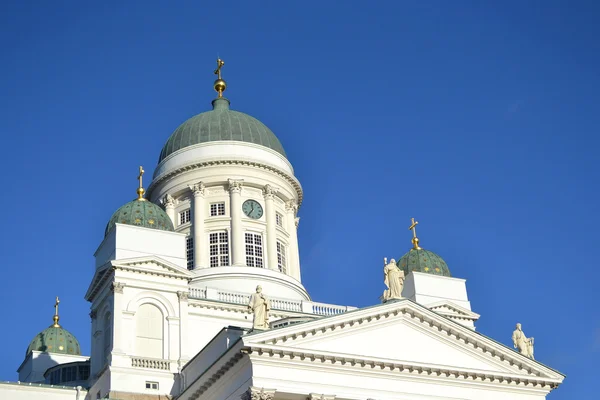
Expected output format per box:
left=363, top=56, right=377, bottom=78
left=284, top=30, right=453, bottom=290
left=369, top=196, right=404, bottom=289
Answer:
left=135, top=303, right=163, bottom=358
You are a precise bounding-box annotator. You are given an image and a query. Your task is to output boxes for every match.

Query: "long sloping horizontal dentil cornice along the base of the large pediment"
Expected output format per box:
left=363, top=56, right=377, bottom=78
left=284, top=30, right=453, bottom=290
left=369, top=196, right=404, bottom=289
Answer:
left=241, top=344, right=560, bottom=391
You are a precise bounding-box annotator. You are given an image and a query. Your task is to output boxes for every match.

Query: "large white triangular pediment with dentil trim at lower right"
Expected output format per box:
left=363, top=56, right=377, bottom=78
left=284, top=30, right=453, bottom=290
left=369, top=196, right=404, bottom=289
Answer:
left=244, top=300, right=562, bottom=381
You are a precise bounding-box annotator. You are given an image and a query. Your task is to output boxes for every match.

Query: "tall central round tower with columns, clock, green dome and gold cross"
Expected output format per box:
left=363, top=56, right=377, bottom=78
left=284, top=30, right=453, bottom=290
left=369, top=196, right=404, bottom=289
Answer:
left=148, top=59, right=309, bottom=300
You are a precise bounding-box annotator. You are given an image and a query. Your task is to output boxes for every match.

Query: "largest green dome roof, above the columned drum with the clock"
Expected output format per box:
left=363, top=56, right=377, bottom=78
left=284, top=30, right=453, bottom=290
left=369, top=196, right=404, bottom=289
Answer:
left=158, top=98, right=286, bottom=163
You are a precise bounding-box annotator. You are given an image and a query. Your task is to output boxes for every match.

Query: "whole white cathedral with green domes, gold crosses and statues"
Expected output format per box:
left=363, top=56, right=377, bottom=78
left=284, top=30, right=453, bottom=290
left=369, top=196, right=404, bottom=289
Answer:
left=0, top=59, right=564, bottom=400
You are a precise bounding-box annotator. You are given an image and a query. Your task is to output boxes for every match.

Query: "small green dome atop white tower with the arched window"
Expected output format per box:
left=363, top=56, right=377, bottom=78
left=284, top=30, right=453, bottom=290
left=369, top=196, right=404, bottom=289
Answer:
left=104, top=199, right=175, bottom=236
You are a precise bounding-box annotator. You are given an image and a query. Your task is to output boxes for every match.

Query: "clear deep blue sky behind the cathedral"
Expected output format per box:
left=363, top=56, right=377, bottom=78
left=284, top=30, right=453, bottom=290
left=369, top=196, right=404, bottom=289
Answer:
left=0, top=1, right=600, bottom=400
